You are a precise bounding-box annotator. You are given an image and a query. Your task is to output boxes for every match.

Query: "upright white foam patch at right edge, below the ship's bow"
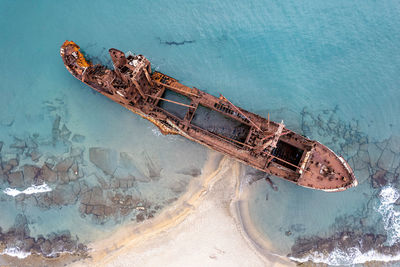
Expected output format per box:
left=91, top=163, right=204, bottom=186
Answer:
left=377, top=186, right=400, bottom=245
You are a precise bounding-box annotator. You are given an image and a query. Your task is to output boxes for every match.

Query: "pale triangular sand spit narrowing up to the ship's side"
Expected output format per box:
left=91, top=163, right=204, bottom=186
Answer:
left=70, top=152, right=293, bottom=266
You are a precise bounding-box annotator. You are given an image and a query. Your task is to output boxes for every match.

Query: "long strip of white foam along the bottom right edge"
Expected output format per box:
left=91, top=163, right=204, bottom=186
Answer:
left=289, top=248, right=400, bottom=266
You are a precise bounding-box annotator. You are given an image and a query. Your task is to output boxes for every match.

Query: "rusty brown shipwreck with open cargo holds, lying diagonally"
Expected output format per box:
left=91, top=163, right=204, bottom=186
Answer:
left=60, top=41, right=357, bottom=192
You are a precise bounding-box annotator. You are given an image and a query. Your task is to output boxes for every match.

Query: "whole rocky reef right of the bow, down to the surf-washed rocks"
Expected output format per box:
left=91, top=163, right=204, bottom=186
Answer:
left=288, top=108, right=400, bottom=264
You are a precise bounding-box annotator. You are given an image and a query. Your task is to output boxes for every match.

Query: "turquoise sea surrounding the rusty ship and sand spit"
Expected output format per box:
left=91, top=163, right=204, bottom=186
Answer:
left=0, top=0, right=400, bottom=266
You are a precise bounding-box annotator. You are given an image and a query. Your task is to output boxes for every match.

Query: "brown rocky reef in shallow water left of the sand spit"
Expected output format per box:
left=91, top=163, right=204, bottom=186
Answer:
left=0, top=112, right=176, bottom=257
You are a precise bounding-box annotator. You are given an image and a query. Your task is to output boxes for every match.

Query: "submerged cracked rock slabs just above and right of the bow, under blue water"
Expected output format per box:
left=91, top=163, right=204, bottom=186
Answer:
left=301, top=107, right=400, bottom=188
